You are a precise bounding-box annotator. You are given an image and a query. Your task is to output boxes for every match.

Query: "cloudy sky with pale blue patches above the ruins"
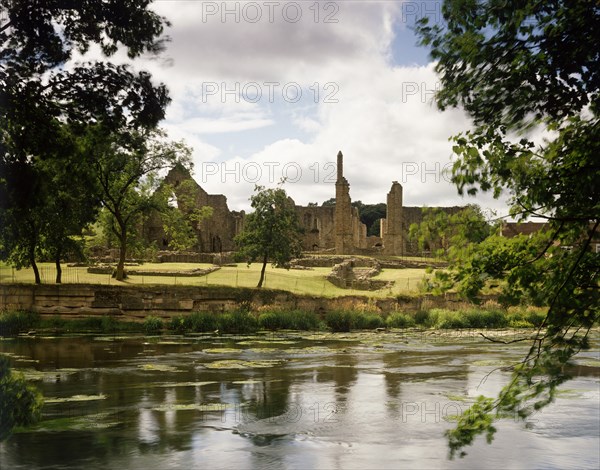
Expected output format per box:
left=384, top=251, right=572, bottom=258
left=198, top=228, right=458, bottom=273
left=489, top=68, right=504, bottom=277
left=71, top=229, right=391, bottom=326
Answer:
left=79, top=0, right=506, bottom=214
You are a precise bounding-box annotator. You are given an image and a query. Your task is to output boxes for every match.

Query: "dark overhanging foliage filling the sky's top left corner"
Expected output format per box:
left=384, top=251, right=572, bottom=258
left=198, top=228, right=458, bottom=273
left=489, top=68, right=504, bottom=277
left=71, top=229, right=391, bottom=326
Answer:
left=0, top=0, right=168, bottom=133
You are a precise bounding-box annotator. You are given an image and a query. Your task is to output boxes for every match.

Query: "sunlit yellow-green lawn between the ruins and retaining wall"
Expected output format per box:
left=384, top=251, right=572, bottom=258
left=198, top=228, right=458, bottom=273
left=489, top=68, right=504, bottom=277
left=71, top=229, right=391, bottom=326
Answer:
left=0, top=263, right=425, bottom=298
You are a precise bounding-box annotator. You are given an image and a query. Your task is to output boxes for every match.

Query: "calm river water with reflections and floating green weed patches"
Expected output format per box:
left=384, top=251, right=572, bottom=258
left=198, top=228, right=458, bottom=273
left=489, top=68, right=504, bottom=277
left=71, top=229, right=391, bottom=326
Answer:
left=0, top=333, right=600, bottom=469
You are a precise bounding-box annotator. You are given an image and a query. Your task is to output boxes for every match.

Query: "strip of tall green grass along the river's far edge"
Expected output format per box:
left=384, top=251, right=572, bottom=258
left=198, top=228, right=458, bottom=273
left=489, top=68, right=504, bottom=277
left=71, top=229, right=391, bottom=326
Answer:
left=0, top=307, right=545, bottom=336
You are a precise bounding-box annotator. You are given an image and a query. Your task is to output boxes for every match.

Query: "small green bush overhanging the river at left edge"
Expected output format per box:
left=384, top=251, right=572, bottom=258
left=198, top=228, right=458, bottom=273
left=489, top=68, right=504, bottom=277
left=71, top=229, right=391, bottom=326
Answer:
left=0, top=354, right=43, bottom=442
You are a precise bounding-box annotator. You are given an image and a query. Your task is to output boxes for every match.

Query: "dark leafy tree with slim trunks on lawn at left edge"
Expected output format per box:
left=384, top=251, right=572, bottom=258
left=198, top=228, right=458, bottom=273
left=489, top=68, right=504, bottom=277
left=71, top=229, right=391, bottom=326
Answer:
left=0, top=125, right=98, bottom=284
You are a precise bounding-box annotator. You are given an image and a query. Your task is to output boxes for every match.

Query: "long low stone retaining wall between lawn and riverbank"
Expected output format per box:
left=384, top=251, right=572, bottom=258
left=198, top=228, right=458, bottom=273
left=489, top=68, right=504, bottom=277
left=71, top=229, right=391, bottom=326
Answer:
left=0, top=284, right=474, bottom=319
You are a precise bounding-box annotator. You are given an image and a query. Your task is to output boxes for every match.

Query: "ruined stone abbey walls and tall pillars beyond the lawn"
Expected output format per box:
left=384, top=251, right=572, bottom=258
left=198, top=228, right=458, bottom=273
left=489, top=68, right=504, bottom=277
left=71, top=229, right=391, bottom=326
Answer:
left=144, top=152, right=462, bottom=256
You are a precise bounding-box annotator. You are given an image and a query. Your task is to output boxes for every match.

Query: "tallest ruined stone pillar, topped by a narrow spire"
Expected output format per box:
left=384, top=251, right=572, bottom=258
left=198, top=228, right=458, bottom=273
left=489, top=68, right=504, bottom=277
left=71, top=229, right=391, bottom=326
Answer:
left=335, top=151, right=354, bottom=255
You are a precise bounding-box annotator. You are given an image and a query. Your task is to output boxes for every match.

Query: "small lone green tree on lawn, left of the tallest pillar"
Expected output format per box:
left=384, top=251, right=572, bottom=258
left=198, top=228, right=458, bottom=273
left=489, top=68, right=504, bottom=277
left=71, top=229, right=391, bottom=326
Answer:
left=235, top=186, right=302, bottom=288
